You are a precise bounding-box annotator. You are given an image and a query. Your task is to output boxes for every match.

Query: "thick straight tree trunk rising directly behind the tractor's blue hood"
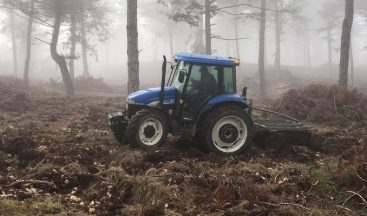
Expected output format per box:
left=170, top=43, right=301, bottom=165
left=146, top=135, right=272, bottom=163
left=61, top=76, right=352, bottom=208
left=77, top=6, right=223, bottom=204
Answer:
left=126, top=0, right=140, bottom=93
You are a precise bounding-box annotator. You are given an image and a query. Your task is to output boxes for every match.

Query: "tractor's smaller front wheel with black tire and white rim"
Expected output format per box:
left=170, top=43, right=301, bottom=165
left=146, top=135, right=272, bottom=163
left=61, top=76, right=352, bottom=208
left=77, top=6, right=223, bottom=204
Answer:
left=127, top=109, right=169, bottom=149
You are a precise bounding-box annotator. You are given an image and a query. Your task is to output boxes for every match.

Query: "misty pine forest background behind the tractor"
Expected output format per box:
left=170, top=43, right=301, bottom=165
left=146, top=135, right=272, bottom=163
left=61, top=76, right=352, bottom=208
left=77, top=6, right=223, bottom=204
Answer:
left=0, top=0, right=367, bottom=92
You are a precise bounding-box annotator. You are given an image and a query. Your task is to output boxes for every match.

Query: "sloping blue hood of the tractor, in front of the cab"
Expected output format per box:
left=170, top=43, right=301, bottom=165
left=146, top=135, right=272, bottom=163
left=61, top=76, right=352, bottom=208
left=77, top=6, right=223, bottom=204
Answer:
left=127, top=87, right=177, bottom=105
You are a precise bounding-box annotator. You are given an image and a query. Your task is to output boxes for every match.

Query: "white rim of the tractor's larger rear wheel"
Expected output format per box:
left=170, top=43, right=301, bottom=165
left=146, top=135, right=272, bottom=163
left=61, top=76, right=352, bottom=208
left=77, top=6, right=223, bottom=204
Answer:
left=212, top=116, right=248, bottom=153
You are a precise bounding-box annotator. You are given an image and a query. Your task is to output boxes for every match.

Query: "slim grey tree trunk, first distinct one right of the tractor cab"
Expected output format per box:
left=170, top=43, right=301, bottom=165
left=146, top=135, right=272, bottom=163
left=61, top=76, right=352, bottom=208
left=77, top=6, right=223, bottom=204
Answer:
left=259, top=0, right=266, bottom=101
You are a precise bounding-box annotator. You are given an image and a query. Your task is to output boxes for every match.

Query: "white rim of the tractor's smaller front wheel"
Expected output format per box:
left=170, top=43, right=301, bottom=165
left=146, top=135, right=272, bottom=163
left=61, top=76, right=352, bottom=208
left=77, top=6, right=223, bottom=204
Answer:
left=139, top=118, right=163, bottom=146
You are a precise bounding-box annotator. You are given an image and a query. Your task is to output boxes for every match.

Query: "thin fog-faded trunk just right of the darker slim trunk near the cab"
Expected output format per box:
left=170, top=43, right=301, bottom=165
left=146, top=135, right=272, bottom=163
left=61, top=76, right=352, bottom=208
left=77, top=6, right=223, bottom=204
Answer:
left=274, top=0, right=282, bottom=76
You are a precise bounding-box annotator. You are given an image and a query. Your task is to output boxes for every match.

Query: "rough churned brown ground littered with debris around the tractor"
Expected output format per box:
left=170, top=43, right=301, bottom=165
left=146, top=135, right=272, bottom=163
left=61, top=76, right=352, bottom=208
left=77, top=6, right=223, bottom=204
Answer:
left=0, top=77, right=367, bottom=216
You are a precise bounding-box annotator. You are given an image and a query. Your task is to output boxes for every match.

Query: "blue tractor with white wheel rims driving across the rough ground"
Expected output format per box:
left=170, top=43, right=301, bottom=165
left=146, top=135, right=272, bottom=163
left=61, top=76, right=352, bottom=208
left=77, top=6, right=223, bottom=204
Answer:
left=109, top=53, right=312, bottom=154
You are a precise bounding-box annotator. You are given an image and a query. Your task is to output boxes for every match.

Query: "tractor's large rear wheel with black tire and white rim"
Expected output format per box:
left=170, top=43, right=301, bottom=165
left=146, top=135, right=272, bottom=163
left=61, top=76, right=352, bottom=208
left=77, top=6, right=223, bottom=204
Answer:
left=202, top=106, right=254, bottom=155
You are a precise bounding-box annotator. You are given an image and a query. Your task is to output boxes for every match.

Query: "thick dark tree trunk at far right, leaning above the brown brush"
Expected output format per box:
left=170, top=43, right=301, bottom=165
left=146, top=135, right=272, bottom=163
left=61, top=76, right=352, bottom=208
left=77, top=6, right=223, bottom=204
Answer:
left=339, top=0, right=354, bottom=89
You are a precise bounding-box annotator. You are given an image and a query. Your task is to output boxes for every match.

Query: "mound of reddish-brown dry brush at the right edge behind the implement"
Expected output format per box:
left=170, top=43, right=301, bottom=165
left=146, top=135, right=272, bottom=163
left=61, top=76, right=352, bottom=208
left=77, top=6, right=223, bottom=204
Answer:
left=273, top=85, right=367, bottom=127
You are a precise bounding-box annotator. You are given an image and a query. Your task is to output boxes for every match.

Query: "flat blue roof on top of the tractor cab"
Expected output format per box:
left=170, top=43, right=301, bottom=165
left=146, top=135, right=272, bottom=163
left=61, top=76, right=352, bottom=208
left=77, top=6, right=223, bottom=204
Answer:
left=174, top=53, right=236, bottom=66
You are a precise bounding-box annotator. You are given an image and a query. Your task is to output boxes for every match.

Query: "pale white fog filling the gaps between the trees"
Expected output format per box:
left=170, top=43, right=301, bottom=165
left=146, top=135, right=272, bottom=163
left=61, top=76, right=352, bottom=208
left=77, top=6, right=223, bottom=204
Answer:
left=0, top=0, right=367, bottom=88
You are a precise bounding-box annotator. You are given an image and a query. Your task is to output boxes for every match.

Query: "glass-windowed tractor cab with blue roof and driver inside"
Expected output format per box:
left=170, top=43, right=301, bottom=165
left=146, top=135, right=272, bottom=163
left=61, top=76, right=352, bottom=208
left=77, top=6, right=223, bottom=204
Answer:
left=167, top=53, right=244, bottom=123
